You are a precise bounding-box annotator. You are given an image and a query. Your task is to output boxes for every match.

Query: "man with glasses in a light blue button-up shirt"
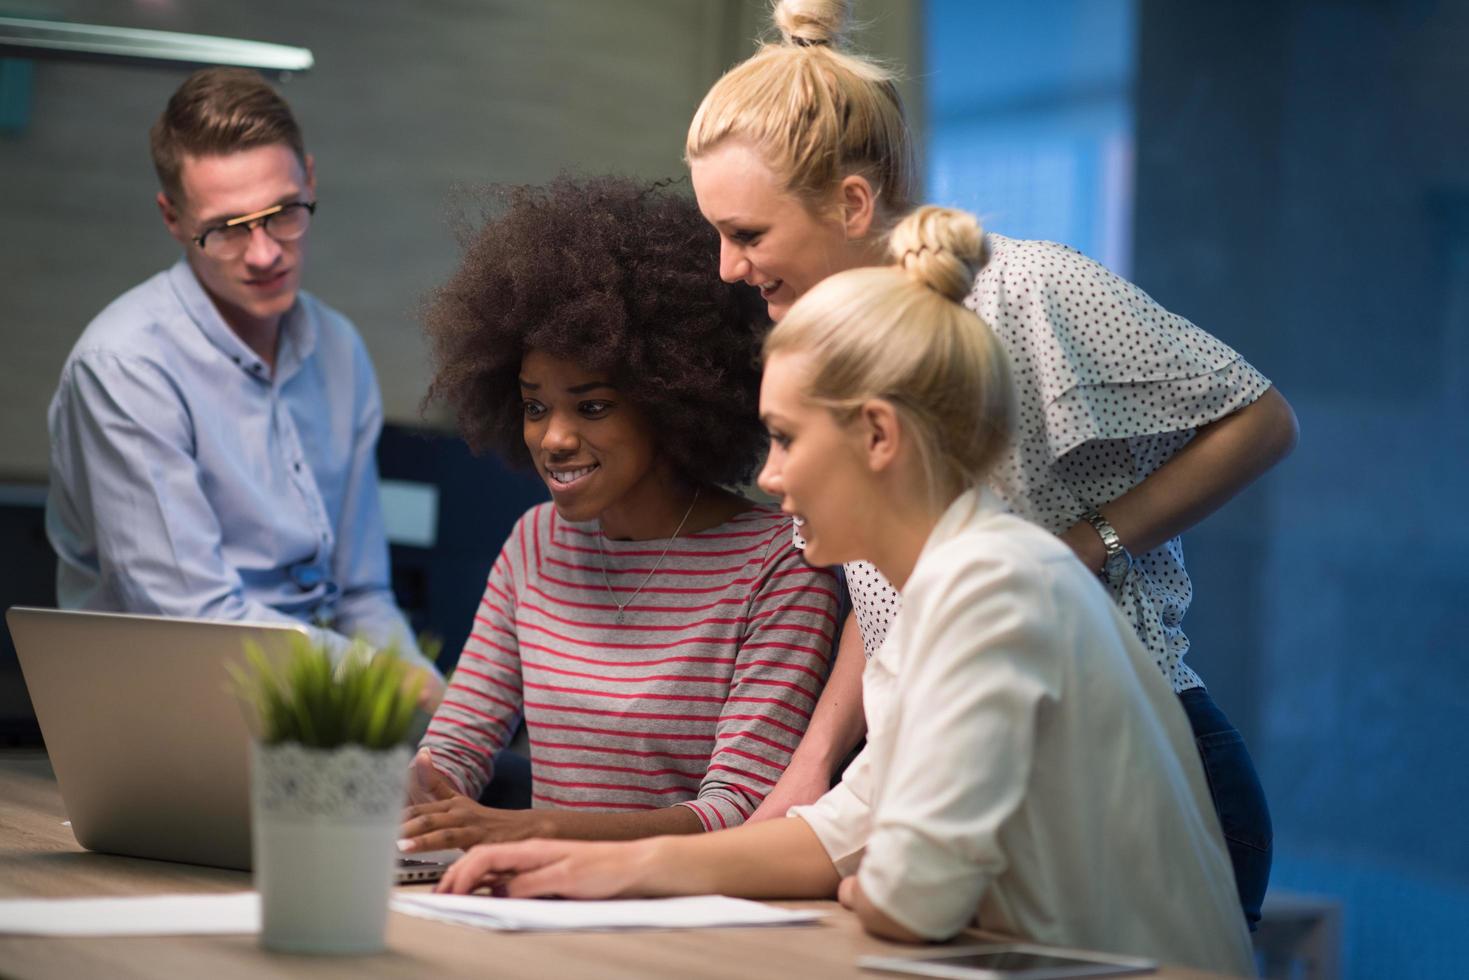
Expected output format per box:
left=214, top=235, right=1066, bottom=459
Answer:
left=46, top=69, right=442, bottom=699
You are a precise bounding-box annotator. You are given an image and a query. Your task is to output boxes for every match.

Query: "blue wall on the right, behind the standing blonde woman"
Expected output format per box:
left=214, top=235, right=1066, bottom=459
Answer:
left=928, top=0, right=1469, bottom=979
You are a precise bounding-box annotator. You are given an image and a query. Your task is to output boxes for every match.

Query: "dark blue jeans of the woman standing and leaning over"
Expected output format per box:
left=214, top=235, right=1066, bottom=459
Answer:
left=1178, top=688, right=1274, bottom=932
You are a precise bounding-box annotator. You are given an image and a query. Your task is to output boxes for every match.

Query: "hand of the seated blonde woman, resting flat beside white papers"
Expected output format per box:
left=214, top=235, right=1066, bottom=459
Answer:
left=435, top=839, right=655, bottom=898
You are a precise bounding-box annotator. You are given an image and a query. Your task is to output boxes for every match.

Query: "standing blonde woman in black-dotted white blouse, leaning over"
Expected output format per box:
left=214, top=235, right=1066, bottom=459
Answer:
left=686, top=0, right=1296, bottom=929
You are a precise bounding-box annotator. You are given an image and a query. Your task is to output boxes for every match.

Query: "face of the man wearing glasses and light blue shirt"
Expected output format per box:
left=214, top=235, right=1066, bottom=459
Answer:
left=159, top=143, right=316, bottom=334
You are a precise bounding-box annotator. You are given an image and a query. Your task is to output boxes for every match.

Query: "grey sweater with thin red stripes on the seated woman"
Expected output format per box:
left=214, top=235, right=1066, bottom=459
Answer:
left=423, top=504, right=836, bottom=830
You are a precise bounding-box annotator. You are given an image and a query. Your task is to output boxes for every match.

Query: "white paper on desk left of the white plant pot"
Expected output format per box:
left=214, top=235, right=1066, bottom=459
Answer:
left=0, top=892, right=260, bottom=936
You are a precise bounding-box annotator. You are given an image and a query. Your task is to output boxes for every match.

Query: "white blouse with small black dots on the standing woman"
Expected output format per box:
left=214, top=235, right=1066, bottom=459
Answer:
left=846, top=235, right=1271, bottom=691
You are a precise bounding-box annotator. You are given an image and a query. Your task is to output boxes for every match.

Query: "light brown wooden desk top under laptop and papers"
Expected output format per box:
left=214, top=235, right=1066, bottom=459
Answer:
left=0, top=752, right=1213, bottom=980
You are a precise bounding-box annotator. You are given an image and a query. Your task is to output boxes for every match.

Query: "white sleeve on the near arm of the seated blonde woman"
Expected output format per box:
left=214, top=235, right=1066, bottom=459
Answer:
left=859, top=549, right=1061, bottom=939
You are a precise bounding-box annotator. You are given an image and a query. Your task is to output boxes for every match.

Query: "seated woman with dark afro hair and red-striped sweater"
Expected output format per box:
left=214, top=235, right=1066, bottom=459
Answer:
left=403, top=178, right=836, bottom=851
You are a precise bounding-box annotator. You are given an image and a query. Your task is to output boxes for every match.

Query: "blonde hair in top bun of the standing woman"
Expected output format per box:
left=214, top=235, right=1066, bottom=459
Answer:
left=685, top=0, right=914, bottom=228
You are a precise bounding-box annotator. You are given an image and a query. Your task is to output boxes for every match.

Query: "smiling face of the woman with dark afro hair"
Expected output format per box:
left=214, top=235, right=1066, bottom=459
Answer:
left=520, top=351, right=672, bottom=538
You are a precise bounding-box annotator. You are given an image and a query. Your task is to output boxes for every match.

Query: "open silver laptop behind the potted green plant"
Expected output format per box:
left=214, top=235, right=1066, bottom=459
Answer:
left=6, top=607, right=457, bottom=882
